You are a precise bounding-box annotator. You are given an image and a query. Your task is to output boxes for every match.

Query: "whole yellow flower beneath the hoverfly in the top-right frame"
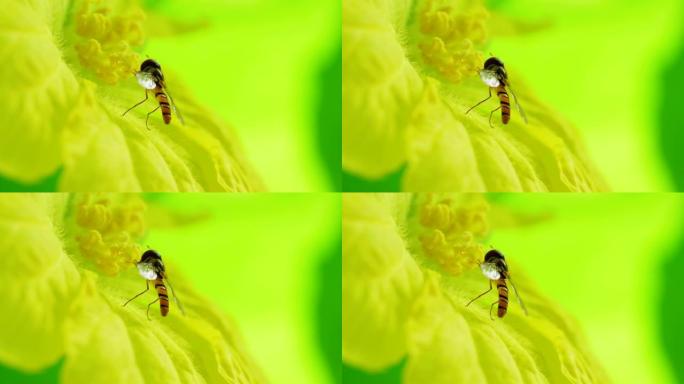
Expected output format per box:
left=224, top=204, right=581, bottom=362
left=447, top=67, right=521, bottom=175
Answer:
left=342, top=0, right=605, bottom=191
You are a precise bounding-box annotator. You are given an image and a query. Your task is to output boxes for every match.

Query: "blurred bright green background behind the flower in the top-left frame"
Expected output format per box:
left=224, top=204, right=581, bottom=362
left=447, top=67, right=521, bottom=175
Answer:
left=0, top=0, right=342, bottom=192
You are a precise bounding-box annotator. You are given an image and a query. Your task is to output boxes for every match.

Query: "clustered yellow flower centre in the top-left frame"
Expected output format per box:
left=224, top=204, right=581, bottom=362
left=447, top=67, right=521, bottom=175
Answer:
left=75, top=0, right=145, bottom=85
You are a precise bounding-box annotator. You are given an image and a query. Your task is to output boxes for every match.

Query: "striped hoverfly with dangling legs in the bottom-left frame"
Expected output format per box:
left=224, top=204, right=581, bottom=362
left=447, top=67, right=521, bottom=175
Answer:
left=123, top=249, right=185, bottom=320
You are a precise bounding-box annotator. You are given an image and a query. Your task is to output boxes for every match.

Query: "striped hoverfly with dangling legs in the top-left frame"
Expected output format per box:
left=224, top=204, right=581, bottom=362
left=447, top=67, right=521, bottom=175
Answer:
left=121, top=59, right=185, bottom=129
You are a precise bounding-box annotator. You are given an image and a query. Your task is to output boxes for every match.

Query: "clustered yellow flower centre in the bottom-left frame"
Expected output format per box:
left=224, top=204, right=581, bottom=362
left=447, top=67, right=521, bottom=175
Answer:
left=76, top=195, right=145, bottom=276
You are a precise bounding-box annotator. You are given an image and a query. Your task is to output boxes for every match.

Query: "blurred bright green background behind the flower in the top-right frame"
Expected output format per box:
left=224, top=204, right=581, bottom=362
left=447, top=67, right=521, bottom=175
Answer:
left=343, top=0, right=684, bottom=192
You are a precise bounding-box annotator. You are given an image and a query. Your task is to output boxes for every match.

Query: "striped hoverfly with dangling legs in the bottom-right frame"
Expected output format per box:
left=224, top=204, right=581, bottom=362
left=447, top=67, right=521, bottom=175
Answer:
left=466, top=249, right=527, bottom=320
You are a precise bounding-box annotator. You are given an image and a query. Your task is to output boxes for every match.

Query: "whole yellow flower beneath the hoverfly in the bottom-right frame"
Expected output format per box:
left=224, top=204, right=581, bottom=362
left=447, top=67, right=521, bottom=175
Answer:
left=342, top=194, right=606, bottom=384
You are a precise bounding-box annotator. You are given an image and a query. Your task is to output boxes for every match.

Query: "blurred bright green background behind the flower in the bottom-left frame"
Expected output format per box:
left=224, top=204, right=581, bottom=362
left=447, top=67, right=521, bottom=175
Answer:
left=0, top=193, right=342, bottom=384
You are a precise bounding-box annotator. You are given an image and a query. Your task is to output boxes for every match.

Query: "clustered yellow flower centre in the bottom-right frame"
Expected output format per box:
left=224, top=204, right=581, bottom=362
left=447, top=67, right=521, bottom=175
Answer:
left=419, top=196, right=489, bottom=275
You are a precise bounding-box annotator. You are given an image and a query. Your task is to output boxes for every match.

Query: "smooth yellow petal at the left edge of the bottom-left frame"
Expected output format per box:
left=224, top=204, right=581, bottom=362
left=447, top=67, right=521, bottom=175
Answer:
left=0, top=194, right=80, bottom=371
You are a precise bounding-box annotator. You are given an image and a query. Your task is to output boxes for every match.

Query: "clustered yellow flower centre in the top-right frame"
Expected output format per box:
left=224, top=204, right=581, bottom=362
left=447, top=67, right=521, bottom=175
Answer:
left=418, top=0, right=489, bottom=83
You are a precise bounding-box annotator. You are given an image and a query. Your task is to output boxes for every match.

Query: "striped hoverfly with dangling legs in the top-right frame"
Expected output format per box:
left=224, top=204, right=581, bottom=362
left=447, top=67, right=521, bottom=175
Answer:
left=466, top=57, right=527, bottom=127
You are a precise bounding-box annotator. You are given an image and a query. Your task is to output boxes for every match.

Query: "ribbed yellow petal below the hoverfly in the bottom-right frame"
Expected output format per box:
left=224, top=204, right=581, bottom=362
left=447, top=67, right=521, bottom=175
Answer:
left=404, top=270, right=607, bottom=384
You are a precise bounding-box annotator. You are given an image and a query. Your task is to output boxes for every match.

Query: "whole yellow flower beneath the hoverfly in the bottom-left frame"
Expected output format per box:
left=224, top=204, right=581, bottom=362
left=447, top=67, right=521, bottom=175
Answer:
left=0, top=194, right=263, bottom=383
